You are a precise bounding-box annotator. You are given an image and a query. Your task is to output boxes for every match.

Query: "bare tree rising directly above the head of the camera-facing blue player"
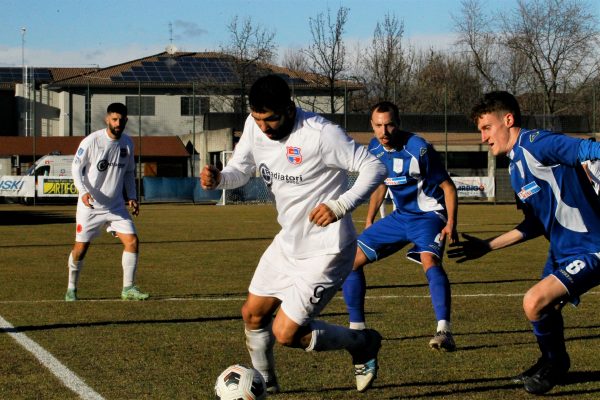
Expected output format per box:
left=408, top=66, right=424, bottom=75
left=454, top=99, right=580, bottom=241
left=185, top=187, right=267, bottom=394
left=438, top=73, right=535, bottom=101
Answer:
left=364, top=14, right=412, bottom=102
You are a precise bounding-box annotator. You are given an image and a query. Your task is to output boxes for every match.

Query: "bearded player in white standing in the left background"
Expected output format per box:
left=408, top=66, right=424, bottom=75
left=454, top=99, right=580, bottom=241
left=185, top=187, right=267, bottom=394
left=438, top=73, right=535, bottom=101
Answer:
left=65, top=103, right=148, bottom=301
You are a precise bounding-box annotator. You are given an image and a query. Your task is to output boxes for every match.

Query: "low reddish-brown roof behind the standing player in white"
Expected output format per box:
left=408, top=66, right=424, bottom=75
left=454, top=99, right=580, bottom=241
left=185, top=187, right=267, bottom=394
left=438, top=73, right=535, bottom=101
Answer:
left=0, top=136, right=189, bottom=157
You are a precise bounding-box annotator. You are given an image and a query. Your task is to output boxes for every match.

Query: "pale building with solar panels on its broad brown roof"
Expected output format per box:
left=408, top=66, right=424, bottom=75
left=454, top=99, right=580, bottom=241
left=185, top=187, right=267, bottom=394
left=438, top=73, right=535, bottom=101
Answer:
left=0, top=52, right=361, bottom=137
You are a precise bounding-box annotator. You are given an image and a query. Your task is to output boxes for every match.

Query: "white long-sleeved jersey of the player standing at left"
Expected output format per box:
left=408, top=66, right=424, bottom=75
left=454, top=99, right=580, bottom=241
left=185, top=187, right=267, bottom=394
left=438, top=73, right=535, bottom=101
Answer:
left=73, top=129, right=137, bottom=210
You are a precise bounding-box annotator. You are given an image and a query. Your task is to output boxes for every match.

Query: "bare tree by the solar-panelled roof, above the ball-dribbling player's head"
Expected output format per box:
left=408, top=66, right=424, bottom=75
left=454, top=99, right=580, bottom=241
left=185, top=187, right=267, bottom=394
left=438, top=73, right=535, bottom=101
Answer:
left=222, top=15, right=276, bottom=114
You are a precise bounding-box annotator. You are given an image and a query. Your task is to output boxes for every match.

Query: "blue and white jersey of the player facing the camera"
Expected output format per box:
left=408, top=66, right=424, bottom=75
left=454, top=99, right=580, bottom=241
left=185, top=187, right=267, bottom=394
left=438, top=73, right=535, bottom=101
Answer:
left=369, top=132, right=449, bottom=215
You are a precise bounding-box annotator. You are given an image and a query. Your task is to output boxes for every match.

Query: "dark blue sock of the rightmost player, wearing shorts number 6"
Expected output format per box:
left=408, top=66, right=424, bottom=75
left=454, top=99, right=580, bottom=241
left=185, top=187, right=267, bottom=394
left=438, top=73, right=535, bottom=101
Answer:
left=531, top=310, right=567, bottom=360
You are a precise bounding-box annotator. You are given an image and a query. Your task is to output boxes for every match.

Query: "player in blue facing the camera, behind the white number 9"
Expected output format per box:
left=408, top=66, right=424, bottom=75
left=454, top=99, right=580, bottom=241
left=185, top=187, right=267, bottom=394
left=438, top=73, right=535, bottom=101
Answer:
left=343, top=101, right=458, bottom=351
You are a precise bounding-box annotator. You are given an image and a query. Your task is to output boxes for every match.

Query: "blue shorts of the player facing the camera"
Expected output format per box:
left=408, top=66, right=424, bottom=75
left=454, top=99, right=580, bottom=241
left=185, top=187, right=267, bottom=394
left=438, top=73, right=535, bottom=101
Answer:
left=358, top=211, right=447, bottom=263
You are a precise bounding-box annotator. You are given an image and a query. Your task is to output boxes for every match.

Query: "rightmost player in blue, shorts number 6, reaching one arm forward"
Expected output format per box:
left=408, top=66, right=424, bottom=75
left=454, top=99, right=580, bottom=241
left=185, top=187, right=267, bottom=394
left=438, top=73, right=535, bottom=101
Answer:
left=448, top=91, right=600, bottom=394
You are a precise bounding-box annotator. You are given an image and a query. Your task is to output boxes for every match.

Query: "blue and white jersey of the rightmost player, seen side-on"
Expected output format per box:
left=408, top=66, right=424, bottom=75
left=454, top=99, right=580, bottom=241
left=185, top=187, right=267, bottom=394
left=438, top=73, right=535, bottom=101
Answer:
left=508, top=129, right=600, bottom=262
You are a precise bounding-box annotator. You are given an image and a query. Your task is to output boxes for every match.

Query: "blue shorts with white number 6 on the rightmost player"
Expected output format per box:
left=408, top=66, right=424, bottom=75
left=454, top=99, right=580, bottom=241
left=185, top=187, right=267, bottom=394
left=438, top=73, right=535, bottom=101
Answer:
left=542, top=254, right=600, bottom=305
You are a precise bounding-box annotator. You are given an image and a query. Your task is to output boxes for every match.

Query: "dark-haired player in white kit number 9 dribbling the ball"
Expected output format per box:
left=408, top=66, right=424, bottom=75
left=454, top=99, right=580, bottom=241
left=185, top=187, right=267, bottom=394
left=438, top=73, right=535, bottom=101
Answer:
left=201, top=75, right=385, bottom=393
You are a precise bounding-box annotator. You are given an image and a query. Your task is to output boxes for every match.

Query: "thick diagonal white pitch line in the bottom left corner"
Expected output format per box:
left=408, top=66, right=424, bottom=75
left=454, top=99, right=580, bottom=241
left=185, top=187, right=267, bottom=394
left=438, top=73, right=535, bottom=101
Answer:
left=0, top=316, right=104, bottom=400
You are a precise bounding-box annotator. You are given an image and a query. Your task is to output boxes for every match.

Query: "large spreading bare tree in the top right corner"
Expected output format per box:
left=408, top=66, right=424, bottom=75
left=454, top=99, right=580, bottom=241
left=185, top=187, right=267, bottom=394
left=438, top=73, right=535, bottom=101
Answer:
left=502, top=0, right=600, bottom=114
